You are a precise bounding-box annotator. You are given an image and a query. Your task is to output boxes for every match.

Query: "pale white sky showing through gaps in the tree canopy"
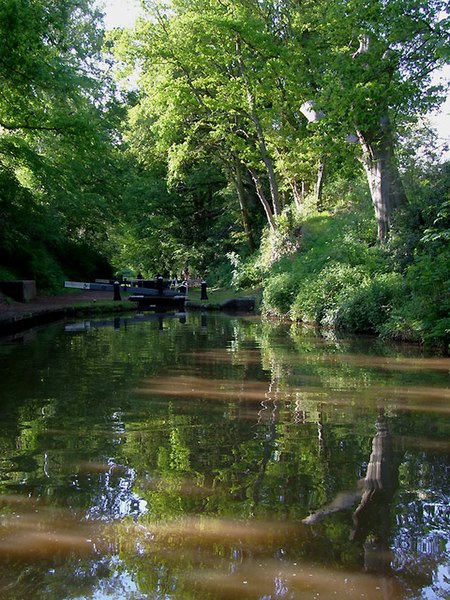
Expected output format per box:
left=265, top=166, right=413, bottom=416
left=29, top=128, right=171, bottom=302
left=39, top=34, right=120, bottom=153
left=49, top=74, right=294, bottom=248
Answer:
left=98, top=0, right=450, bottom=158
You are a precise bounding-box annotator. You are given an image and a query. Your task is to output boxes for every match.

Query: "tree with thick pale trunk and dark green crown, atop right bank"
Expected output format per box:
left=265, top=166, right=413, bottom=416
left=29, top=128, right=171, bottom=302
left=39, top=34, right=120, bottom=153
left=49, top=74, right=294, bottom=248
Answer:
left=298, top=0, right=449, bottom=242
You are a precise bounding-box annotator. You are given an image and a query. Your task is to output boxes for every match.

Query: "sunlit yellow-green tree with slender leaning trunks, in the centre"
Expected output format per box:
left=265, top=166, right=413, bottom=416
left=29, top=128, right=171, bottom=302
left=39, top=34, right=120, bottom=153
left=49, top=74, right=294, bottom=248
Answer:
left=116, top=0, right=302, bottom=234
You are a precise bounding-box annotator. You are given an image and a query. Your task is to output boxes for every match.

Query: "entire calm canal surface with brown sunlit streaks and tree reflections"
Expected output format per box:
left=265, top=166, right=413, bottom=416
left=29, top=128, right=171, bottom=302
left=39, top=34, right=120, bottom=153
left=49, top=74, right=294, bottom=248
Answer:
left=0, top=313, right=450, bottom=600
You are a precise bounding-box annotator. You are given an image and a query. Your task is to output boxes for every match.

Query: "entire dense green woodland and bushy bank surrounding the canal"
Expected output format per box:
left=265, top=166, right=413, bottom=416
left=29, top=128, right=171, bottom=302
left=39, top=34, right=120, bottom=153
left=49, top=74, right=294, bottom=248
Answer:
left=0, top=0, right=450, bottom=351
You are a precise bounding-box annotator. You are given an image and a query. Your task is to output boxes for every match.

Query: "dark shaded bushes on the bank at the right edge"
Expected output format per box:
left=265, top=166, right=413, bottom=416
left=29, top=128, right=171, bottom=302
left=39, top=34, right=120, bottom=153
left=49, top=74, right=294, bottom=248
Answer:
left=381, top=162, right=450, bottom=352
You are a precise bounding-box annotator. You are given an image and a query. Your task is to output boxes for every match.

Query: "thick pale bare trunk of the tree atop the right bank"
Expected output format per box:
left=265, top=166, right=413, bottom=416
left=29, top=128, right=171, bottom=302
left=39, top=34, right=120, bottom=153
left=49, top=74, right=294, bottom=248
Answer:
left=356, top=116, right=406, bottom=242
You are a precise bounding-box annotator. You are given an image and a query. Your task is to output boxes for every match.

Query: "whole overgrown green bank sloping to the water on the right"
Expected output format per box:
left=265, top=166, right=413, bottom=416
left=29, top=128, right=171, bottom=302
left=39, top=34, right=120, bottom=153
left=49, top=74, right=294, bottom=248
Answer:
left=227, top=169, right=450, bottom=353
